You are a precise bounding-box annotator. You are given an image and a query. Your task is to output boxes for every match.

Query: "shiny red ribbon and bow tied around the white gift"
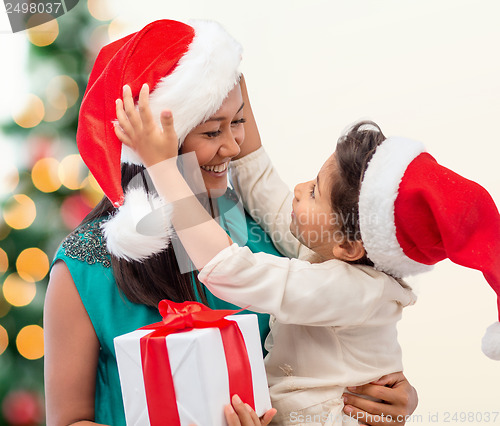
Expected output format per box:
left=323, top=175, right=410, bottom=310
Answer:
left=140, top=300, right=255, bottom=426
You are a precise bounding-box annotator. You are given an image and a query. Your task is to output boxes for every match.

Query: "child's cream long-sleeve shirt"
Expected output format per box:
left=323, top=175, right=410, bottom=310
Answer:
left=199, top=149, right=416, bottom=425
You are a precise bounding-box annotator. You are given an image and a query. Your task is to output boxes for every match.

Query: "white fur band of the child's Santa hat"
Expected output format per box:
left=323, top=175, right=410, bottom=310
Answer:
left=359, top=137, right=432, bottom=278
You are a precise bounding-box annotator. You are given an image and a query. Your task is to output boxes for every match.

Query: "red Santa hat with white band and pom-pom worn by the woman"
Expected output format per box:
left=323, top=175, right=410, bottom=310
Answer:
left=76, top=20, right=242, bottom=260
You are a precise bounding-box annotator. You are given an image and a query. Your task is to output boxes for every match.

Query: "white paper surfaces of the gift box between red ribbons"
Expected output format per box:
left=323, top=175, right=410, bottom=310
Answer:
left=114, top=314, right=271, bottom=426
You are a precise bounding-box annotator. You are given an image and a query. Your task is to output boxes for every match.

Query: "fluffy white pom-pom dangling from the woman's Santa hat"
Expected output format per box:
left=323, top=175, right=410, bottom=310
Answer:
left=101, top=188, right=172, bottom=261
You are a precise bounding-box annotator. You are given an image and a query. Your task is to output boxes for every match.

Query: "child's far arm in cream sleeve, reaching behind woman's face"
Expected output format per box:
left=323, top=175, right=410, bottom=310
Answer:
left=229, top=76, right=312, bottom=258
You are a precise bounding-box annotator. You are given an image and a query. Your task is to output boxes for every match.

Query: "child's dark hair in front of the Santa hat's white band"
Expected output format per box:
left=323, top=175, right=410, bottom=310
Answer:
left=331, top=121, right=385, bottom=266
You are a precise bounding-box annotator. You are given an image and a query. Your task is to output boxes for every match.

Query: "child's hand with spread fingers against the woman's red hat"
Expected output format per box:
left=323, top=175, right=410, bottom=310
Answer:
left=115, top=84, right=179, bottom=167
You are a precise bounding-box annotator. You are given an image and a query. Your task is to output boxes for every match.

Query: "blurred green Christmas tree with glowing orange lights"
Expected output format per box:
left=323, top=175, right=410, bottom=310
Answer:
left=0, top=0, right=118, bottom=425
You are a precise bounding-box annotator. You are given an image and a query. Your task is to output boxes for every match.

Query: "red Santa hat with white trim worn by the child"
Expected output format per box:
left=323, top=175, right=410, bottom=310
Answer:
left=359, top=138, right=500, bottom=360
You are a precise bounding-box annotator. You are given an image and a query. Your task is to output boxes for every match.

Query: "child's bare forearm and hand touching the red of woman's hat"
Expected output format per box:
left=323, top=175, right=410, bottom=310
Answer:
left=115, top=84, right=232, bottom=270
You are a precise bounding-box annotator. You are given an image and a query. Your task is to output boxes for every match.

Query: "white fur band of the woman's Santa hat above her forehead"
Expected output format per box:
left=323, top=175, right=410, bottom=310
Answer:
left=122, top=20, right=242, bottom=164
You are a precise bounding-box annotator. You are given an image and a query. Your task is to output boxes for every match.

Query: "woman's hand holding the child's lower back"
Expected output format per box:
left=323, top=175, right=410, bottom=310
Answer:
left=343, top=372, right=418, bottom=426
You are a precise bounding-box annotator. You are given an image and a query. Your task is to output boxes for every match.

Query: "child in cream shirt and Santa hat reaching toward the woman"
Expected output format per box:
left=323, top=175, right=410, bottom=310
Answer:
left=115, top=81, right=500, bottom=424
